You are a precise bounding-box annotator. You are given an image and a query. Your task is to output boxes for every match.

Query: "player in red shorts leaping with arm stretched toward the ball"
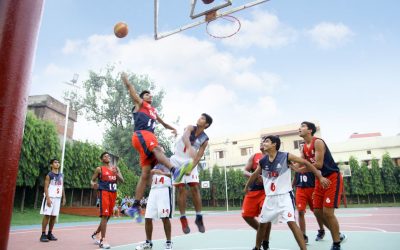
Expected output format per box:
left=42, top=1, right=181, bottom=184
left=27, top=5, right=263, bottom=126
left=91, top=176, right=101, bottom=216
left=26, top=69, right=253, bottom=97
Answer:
left=122, top=73, right=192, bottom=217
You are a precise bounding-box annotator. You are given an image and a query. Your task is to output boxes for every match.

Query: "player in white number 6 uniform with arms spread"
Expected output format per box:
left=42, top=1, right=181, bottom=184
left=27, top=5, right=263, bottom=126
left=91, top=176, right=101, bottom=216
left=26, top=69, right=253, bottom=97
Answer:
left=245, top=135, right=330, bottom=250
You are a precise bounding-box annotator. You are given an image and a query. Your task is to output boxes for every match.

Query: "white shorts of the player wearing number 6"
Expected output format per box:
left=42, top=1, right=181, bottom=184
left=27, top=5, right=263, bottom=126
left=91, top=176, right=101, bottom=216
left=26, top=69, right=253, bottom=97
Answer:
left=259, top=192, right=296, bottom=224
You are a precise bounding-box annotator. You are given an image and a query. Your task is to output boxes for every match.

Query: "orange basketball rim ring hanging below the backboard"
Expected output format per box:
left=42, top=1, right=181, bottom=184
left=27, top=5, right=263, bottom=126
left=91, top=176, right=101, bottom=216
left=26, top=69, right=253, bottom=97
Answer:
left=205, top=10, right=242, bottom=39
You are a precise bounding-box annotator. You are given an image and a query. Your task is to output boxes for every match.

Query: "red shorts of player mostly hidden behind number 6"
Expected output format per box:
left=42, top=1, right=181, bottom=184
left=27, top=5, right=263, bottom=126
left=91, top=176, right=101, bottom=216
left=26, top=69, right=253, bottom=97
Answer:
left=242, top=190, right=265, bottom=217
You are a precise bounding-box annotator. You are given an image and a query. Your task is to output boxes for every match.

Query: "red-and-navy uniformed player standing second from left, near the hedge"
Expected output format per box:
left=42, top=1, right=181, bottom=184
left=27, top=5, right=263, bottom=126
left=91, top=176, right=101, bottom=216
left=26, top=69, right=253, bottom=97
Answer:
left=90, top=152, right=124, bottom=249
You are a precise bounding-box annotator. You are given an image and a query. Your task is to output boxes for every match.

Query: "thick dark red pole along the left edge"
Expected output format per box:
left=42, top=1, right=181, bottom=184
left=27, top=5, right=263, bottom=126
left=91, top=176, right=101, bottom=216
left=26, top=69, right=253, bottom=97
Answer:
left=0, top=0, right=43, bottom=249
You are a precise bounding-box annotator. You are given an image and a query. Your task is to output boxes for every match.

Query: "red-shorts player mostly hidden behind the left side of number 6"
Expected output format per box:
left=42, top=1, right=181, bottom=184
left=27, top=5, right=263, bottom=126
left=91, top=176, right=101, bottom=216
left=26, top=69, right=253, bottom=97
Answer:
left=242, top=143, right=271, bottom=249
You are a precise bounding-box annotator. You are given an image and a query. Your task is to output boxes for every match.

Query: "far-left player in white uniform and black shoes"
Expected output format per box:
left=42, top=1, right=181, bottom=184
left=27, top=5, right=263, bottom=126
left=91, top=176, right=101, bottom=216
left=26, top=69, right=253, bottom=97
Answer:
left=40, top=159, right=66, bottom=242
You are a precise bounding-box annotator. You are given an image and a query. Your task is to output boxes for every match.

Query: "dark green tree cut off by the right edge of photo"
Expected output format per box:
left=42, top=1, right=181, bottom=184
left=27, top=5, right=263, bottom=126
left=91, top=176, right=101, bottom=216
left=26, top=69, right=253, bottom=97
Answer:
left=382, top=153, right=400, bottom=202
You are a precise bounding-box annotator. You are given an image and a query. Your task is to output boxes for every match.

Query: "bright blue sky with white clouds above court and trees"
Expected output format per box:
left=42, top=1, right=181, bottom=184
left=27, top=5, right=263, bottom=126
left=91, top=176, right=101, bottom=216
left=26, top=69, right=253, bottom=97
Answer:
left=30, top=0, right=400, bottom=144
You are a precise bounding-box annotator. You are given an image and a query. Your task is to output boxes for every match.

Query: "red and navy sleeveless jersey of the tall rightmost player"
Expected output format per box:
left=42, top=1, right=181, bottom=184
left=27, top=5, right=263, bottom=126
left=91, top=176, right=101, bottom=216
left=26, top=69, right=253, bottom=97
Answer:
left=303, top=137, right=340, bottom=177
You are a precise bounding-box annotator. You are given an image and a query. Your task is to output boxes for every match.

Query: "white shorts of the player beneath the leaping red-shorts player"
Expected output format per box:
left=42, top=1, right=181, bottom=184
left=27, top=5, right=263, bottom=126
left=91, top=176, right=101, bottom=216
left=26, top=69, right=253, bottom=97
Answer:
left=144, top=187, right=172, bottom=219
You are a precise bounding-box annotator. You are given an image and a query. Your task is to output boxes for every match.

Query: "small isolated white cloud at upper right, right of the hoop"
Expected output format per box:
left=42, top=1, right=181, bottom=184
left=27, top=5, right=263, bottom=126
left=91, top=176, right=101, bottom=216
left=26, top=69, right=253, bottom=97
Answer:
left=307, top=22, right=354, bottom=49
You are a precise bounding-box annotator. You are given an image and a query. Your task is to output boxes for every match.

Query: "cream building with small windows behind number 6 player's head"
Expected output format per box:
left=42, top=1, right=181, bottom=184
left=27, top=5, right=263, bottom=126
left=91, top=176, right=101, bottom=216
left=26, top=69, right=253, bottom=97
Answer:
left=206, top=122, right=321, bottom=169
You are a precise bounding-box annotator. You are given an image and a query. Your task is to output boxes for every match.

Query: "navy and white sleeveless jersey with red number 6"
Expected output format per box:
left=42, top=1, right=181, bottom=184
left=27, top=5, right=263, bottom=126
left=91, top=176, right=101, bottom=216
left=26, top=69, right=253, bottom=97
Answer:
left=259, top=151, right=292, bottom=196
